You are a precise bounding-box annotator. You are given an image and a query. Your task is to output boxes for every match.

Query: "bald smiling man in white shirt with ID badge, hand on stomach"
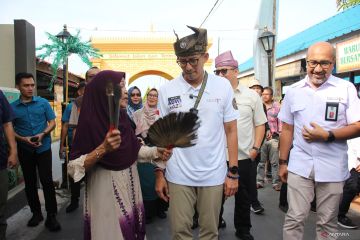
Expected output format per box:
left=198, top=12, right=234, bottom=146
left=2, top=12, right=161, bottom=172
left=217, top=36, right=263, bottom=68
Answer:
left=278, top=42, right=360, bottom=240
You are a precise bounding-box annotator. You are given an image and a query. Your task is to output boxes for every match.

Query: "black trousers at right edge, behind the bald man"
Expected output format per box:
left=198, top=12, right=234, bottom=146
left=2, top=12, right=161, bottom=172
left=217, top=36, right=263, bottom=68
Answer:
left=338, top=168, right=360, bottom=217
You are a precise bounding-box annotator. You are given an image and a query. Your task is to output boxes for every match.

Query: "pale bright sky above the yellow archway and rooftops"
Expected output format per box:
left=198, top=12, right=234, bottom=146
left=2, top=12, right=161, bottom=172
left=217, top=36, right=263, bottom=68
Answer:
left=0, top=0, right=337, bottom=93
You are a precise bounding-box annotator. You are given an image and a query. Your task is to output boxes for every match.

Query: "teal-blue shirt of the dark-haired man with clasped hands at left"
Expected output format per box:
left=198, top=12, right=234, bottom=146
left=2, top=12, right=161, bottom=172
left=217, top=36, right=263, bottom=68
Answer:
left=11, top=97, right=55, bottom=153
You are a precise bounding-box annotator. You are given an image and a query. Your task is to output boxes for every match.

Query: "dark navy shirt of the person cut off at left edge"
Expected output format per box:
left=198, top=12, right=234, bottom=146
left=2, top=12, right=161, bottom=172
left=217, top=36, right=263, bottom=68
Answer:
left=0, top=90, right=14, bottom=170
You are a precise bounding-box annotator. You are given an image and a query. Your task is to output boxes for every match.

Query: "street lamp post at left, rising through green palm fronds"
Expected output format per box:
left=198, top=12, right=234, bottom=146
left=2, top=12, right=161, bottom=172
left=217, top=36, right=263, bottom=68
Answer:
left=56, top=24, right=71, bottom=189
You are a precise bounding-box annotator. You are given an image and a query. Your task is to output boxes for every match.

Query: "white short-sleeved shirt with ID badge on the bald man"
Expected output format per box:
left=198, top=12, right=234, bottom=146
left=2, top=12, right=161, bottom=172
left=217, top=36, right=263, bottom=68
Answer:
left=278, top=75, right=360, bottom=182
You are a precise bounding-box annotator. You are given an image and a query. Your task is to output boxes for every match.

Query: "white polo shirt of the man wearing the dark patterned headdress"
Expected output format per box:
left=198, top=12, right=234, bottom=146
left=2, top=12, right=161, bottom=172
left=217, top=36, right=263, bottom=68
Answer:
left=159, top=74, right=238, bottom=186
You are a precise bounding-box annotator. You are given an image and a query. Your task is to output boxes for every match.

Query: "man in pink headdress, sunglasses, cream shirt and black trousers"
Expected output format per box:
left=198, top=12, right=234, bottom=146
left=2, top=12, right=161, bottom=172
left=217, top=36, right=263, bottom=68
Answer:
left=215, top=51, right=267, bottom=240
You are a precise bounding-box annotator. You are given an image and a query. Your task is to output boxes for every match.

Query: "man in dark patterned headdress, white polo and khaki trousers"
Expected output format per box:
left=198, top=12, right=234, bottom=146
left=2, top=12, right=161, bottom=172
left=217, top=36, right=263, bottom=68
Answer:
left=156, top=27, right=239, bottom=240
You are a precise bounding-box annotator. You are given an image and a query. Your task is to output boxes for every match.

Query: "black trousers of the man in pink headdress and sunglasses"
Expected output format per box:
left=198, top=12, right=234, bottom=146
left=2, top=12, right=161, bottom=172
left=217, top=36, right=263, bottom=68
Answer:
left=220, top=159, right=254, bottom=232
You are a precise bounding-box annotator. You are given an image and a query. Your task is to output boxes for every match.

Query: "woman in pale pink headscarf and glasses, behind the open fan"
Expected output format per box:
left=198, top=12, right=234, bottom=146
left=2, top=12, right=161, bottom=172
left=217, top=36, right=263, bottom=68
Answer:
left=133, top=88, right=167, bottom=223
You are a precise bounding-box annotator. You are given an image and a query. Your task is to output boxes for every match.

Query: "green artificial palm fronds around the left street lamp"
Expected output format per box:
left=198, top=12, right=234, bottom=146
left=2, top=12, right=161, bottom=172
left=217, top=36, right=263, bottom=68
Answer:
left=36, top=31, right=101, bottom=89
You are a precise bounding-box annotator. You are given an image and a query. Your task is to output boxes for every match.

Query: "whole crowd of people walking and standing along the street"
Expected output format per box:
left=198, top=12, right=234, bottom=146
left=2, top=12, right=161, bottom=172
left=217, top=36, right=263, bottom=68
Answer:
left=0, top=24, right=360, bottom=240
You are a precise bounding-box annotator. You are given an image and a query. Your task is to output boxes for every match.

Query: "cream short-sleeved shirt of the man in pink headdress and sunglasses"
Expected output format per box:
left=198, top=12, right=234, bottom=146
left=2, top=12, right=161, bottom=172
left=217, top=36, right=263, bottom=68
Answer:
left=234, top=84, right=267, bottom=160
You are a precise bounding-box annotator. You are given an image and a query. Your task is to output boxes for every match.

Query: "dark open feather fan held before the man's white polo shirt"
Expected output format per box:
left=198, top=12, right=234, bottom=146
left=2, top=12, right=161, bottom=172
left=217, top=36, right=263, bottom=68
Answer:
left=148, top=112, right=200, bottom=149
